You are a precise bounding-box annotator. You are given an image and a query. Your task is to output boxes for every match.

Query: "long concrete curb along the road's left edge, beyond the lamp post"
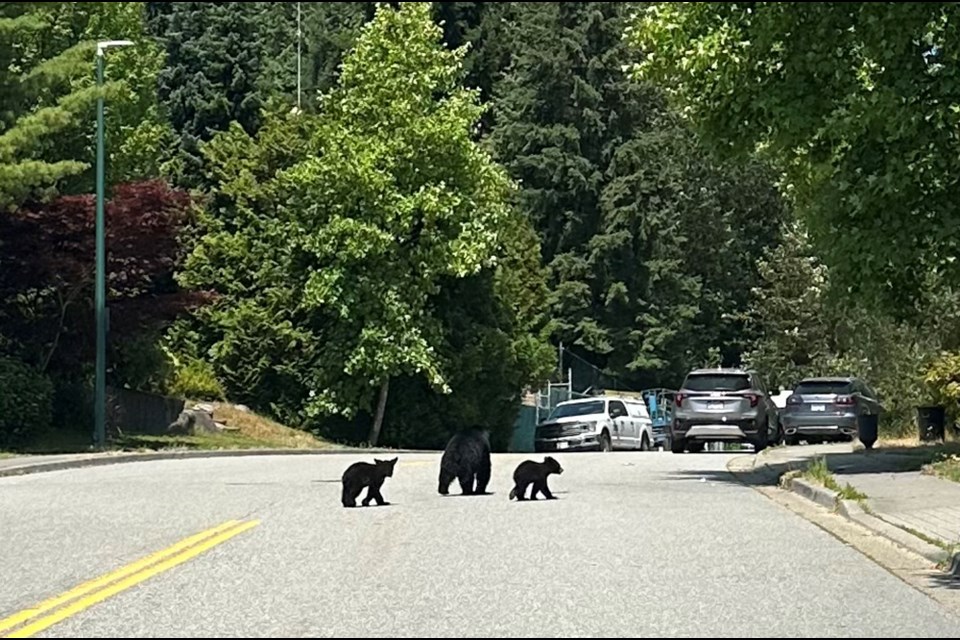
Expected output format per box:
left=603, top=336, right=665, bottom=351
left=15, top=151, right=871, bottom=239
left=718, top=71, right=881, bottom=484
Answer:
left=0, top=448, right=440, bottom=478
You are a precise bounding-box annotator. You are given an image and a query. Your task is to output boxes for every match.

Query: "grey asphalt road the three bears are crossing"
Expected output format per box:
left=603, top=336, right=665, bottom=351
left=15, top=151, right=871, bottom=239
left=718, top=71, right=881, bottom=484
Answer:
left=0, top=452, right=960, bottom=638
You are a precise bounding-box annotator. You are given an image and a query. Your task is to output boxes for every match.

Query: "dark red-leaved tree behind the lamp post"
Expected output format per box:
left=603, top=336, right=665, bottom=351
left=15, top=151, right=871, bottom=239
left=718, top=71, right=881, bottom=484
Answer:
left=0, top=180, right=214, bottom=371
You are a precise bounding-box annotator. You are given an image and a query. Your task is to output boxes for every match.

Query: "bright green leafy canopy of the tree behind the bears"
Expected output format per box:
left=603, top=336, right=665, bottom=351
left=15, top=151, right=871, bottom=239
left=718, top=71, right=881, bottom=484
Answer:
left=176, top=3, right=511, bottom=428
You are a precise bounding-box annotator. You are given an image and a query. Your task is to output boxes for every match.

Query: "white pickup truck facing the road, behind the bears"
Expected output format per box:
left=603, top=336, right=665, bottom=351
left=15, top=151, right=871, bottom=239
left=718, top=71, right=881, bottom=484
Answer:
left=534, top=396, right=653, bottom=452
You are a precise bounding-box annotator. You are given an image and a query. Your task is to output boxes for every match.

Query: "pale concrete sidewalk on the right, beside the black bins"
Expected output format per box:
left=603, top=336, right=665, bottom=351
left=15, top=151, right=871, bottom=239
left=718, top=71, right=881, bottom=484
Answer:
left=729, top=444, right=960, bottom=562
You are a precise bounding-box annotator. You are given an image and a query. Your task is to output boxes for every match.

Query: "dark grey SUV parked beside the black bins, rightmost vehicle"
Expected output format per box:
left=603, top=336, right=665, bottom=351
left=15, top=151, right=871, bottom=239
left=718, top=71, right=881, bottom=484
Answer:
left=781, top=377, right=883, bottom=445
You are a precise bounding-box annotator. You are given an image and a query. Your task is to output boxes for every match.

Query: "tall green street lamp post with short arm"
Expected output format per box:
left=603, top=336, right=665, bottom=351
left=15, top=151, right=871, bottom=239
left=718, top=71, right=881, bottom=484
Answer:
left=93, top=40, right=133, bottom=447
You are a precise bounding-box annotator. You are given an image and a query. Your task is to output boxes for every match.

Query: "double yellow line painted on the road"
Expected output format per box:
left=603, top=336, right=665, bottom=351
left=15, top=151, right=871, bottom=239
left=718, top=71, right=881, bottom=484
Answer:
left=0, top=520, right=260, bottom=638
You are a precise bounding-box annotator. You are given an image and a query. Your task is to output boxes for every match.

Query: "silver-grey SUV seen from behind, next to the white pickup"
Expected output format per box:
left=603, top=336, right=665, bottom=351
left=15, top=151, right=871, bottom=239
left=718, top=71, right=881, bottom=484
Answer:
left=670, top=369, right=781, bottom=453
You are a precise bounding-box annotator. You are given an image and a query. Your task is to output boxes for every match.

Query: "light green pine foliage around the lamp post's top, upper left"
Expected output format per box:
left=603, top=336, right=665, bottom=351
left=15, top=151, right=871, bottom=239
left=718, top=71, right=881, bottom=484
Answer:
left=0, top=2, right=165, bottom=210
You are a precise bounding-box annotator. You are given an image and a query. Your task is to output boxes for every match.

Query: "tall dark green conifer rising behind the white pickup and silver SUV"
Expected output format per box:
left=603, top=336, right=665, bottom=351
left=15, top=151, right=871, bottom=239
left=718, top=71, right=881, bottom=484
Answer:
left=491, top=2, right=784, bottom=387
